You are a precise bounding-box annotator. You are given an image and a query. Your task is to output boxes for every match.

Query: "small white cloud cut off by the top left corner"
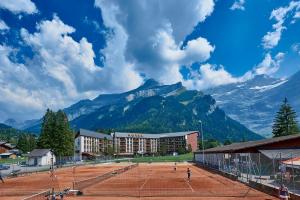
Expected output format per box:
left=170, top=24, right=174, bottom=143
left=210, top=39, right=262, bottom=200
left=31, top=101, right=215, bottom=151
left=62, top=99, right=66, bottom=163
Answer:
left=0, top=0, right=38, bottom=14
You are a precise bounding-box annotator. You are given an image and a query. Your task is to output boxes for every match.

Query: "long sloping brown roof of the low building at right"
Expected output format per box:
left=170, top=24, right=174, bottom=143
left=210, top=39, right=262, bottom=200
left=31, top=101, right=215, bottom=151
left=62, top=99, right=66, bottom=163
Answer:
left=201, top=134, right=300, bottom=153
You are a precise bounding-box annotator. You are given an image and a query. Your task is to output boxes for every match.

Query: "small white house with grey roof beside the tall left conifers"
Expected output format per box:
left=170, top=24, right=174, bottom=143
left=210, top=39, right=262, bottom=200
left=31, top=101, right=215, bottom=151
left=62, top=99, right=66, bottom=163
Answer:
left=28, top=149, right=56, bottom=166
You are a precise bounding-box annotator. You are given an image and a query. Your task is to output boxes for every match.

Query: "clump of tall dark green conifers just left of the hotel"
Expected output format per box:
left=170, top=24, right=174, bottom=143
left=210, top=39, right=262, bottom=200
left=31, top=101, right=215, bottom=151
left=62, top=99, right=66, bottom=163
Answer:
left=37, top=109, right=74, bottom=156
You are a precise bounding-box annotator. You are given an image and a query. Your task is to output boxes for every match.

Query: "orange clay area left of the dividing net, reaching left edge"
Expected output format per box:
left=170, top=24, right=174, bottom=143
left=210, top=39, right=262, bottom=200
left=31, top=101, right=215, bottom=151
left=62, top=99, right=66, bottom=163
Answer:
left=0, top=164, right=128, bottom=199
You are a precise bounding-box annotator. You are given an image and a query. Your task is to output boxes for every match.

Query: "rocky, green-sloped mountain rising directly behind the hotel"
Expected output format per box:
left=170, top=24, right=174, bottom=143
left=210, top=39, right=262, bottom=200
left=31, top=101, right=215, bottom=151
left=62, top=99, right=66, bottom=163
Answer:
left=25, top=79, right=262, bottom=141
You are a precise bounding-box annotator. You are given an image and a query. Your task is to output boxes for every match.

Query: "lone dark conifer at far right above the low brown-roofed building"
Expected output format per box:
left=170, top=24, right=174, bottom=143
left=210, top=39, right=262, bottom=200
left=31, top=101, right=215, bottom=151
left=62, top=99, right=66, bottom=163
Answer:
left=272, top=98, right=299, bottom=137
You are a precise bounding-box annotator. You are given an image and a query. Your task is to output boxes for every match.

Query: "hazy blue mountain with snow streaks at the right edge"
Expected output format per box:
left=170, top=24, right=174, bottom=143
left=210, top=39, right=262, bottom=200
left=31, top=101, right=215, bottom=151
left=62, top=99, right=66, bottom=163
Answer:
left=204, top=72, right=300, bottom=137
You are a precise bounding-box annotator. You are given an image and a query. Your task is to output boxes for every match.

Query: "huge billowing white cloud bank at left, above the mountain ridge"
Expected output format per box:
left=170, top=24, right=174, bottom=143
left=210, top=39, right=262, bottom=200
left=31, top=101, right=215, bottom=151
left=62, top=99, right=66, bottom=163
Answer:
left=0, top=16, right=142, bottom=120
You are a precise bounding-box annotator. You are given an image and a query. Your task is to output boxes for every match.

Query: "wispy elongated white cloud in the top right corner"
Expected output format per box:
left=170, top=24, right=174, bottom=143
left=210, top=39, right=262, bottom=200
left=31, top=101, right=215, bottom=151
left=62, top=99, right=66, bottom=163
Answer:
left=262, top=1, right=300, bottom=49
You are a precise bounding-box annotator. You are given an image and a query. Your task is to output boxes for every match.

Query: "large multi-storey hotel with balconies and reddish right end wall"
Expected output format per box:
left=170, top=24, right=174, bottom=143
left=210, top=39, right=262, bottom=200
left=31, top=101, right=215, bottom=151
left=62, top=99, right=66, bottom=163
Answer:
left=75, top=129, right=199, bottom=159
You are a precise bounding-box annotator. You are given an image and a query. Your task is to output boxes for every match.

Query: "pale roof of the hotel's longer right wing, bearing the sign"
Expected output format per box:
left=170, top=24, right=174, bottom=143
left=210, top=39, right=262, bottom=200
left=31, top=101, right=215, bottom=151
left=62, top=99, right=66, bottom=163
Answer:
left=114, top=131, right=198, bottom=138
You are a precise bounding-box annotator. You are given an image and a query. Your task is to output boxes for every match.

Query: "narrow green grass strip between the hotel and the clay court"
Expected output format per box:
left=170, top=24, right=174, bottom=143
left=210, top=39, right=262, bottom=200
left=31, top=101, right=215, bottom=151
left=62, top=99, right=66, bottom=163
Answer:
left=131, top=153, right=194, bottom=162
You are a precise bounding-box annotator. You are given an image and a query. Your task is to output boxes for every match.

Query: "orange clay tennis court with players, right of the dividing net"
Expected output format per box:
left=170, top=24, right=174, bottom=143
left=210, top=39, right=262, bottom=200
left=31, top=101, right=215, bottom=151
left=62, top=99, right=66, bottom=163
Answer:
left=81, top=163, right=276, bottom=200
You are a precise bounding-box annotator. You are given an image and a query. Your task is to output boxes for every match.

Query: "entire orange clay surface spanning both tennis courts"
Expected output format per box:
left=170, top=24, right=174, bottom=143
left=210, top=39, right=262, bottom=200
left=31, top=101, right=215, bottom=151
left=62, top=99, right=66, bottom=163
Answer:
left=0, top=163, right=276, bottom=200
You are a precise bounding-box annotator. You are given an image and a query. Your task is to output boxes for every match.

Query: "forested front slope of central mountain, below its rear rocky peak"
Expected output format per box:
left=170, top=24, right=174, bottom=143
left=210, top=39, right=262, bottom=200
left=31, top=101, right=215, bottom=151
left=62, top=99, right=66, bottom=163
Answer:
left=72, top=89, right=263, bottom=142
